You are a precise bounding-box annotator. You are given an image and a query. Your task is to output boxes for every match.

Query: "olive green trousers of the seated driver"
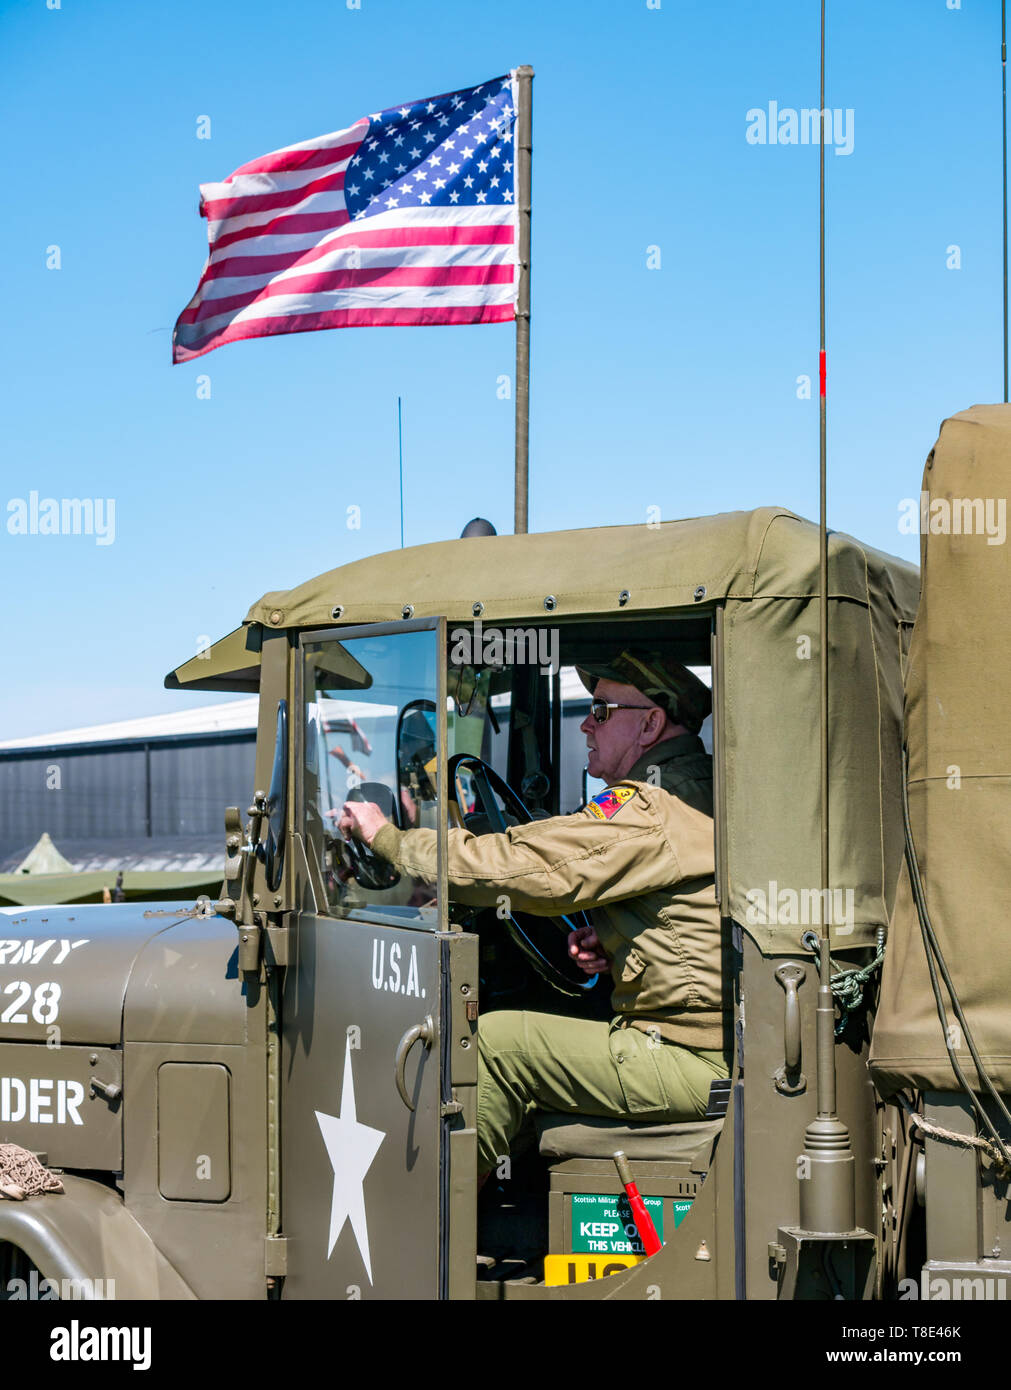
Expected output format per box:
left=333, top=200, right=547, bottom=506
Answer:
left=477, top=1011, right=727, bottom=1175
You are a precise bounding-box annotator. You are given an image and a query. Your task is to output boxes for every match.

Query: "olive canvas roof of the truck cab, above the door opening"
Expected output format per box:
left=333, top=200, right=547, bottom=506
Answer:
left=245, top=507, right=918, bottom=628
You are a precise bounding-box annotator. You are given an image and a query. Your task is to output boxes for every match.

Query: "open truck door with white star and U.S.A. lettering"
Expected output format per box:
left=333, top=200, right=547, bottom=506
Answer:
left=281, top=619, right=477, bottom=1298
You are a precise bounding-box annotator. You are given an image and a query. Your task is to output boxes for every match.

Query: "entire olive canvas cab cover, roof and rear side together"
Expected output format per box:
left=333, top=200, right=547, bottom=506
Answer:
left=246, top=507, right=919, bottom=952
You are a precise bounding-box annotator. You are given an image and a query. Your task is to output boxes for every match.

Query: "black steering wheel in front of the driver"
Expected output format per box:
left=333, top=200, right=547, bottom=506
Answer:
left=446, top=753, right=598, bottom=998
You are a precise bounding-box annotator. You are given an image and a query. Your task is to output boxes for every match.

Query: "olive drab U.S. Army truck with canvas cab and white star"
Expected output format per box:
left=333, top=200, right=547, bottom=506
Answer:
left=0, top=406, right=1011, bottom=1300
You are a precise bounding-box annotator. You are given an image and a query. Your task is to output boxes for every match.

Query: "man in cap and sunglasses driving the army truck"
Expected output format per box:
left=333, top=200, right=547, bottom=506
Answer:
left=339, top=649, right=727, bottom=1175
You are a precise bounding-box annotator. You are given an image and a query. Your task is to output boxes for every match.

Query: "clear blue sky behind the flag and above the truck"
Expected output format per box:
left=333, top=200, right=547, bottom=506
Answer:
left=0, top=0, right=1003, bottom=738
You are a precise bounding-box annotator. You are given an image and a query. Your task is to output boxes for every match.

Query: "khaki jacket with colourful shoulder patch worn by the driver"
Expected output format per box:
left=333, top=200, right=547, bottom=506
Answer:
left=373, top=734, right=723, bottom=1051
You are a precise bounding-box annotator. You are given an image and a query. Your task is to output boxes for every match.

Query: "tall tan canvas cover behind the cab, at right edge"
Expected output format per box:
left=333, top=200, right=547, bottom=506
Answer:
left=871, top=406, right=1011, bottom=1095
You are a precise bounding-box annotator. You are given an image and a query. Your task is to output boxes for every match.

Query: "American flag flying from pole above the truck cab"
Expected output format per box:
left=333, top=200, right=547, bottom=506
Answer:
left=172, top=74, right=517, bottom=361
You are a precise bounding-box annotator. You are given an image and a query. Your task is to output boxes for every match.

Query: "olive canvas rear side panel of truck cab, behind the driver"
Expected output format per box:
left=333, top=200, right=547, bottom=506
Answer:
left=722, top=520, right=919, bottom=955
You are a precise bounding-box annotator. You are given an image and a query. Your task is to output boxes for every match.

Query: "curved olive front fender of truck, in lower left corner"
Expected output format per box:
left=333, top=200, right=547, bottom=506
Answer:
left=0, top=1176, right=196, bottom=1300
